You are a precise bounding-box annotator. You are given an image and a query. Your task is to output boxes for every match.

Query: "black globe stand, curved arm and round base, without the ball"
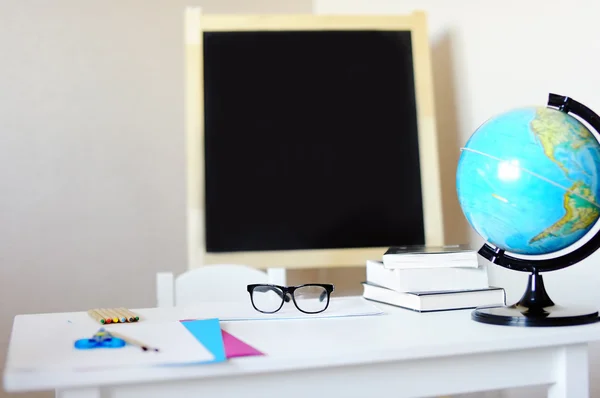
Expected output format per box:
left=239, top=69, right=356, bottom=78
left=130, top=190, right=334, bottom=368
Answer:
left=471, top=94, right=600, bottom=326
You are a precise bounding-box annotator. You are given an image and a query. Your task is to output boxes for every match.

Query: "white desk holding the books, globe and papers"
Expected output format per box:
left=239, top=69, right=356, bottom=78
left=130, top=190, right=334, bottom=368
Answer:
left=4, top=298, right=600, bottom=398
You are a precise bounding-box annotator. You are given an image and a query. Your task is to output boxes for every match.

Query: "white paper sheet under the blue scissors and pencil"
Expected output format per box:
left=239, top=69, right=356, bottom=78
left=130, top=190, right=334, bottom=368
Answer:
left=7, top=322, right=214, bottom=370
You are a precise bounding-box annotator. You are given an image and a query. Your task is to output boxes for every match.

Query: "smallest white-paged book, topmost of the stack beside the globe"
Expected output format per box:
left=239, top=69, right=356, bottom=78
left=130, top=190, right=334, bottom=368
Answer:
left=382, top=245, right=479, bottom=268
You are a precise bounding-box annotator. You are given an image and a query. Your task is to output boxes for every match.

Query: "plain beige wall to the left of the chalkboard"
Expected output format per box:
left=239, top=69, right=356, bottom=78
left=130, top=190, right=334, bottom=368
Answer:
left=0, top=0, right=311, bottom=397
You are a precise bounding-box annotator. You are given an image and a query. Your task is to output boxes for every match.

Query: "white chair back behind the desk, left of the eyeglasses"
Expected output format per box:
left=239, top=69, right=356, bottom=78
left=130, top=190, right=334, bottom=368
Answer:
left=156, top=264, right=269, bottom=307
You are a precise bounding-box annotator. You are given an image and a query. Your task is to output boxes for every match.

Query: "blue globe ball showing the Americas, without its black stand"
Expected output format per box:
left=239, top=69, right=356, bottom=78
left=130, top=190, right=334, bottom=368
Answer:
left=456, top=107, right=600, bottom=255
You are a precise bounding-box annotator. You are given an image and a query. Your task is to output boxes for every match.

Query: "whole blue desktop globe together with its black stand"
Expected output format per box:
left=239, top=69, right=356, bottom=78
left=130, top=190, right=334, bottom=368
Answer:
left=456, top=93, right=600, bottom=326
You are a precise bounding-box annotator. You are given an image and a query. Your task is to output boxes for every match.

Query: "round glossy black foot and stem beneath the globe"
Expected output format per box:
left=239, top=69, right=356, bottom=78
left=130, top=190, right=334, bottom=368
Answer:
left=471, top=271, right=600, bottom=326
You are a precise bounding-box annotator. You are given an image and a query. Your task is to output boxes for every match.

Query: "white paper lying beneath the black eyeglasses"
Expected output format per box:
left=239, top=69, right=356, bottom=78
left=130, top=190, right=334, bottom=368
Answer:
left=181, top=297, right=383, bottom=321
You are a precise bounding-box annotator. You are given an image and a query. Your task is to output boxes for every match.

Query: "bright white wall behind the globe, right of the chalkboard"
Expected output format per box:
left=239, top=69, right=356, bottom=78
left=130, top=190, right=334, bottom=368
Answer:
left=313, top=0, right=600, bottom=398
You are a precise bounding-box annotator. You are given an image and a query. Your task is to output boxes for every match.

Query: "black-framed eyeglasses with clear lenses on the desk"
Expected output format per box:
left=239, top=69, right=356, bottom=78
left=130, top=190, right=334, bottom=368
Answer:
left=248, top=283, right=334, bottom=314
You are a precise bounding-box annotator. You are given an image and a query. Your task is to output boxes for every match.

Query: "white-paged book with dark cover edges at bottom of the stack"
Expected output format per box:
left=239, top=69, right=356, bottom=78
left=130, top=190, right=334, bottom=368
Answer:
left=363, top=283, right=506, bottom=312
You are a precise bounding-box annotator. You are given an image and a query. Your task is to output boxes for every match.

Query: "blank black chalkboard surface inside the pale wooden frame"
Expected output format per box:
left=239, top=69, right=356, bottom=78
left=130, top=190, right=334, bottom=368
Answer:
left=203, top=30, right=425, bottom=252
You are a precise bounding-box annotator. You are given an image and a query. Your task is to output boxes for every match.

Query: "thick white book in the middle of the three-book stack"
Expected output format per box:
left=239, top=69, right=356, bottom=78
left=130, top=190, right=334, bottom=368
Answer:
left=366, top=260, right=488, bottom=292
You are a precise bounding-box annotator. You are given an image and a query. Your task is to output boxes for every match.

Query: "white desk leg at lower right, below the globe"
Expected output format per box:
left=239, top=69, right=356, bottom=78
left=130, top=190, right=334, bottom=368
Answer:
left=548, top=344, right=590, bottom=398
